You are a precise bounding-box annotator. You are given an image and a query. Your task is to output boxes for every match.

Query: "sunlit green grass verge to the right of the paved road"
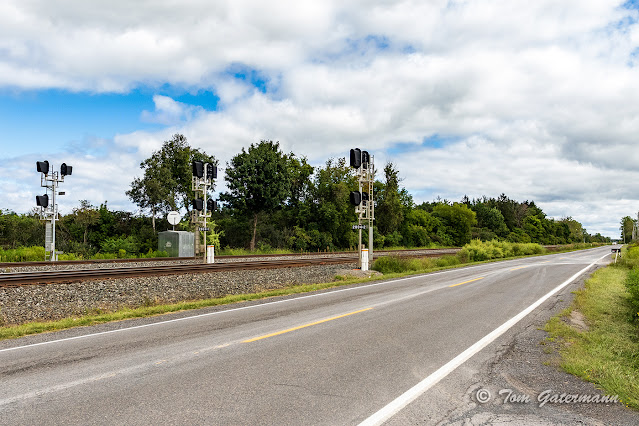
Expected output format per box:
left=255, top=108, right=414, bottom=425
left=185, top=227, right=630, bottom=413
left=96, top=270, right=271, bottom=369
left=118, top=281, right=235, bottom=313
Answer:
left=545, top=267, right=639, bottom=409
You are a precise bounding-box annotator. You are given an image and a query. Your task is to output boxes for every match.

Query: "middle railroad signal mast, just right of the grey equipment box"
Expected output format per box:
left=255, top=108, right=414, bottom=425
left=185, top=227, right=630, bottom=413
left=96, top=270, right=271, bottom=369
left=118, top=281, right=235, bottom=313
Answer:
left=191, top=161, right=217, bottom=263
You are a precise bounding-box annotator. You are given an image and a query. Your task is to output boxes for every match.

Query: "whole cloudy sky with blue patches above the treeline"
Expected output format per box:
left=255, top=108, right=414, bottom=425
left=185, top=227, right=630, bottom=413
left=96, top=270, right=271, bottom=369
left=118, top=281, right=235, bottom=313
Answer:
left=0, top=0, right=639, bottom=238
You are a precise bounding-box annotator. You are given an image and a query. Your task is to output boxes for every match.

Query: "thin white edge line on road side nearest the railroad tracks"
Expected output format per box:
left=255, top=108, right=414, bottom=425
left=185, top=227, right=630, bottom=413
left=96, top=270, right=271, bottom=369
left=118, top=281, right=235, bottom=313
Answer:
left=0, top=248, right=605, bottom=353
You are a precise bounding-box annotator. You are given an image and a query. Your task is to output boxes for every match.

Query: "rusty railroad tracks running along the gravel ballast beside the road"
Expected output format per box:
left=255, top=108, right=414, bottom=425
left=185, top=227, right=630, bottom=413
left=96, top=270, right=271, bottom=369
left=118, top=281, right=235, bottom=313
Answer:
left=0, top=249, right=459, bottom=287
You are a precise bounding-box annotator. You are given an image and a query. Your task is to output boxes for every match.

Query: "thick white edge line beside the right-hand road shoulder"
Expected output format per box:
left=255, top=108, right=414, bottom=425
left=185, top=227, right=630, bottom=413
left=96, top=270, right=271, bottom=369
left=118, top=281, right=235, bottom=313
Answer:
left=360, top=253, right=610, bottom=426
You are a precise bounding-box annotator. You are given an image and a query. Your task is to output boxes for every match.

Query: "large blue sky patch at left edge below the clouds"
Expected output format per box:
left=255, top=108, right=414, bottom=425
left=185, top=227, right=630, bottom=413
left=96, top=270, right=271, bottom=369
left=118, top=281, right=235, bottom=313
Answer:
left=0, top=84, right=224, bottom=157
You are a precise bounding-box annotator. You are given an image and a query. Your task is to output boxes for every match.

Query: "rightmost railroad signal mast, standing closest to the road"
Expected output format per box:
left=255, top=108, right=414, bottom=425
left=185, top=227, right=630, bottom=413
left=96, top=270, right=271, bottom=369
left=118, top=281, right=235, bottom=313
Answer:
left=350, top=148, right=375, bottom=270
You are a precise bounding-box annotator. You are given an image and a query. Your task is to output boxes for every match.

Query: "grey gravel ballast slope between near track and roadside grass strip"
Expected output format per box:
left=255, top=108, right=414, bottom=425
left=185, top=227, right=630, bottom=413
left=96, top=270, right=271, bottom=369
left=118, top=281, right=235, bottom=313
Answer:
left=0, top=263, right=357, bottom=325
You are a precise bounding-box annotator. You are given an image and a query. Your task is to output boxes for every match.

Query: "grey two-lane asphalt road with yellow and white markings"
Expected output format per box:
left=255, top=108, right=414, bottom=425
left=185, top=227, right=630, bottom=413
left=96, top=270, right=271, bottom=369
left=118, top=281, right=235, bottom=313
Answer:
left=0, top=247, right=632, bottom=425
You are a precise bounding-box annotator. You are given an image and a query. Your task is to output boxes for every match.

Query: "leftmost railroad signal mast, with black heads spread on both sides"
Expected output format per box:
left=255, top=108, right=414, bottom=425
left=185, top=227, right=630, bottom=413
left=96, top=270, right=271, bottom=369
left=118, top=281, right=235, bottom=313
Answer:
left=36, top=160, right=73, bottom=261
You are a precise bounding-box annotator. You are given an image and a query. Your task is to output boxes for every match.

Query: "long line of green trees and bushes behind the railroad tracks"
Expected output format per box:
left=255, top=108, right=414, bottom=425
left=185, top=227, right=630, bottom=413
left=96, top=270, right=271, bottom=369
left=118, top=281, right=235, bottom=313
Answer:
left=0, top=135, right=609, bottom=257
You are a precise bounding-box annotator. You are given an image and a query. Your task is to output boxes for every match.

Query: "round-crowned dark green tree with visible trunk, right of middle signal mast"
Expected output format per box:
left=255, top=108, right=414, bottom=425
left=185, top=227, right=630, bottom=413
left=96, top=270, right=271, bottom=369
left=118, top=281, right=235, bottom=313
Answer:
left=220, top=141, right=291, bottom=250
